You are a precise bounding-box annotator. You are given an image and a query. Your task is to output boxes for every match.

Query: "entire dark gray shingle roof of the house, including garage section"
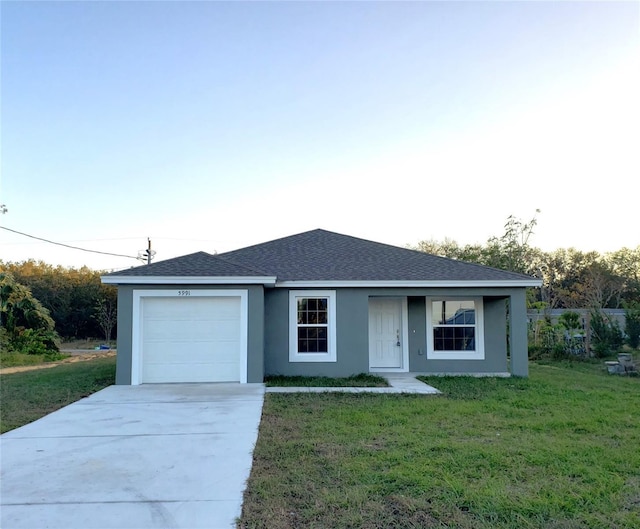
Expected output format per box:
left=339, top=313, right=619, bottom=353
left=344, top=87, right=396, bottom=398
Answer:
left=106, top=229, right=533, bottom=283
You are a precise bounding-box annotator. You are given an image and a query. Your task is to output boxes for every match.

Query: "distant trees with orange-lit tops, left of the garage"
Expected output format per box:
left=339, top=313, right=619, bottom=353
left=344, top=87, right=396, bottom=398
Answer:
left=0, top=260, right=117, bottom=340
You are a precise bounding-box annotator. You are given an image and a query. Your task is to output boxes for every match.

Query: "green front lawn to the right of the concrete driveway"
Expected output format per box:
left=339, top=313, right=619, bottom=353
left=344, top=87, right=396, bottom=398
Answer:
left=239, top=363, right=640, bottom=529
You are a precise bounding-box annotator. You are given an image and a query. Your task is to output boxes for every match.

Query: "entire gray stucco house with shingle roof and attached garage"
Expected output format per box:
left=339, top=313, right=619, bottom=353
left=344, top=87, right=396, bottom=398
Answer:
left=102, top=229, right=541, bottom=384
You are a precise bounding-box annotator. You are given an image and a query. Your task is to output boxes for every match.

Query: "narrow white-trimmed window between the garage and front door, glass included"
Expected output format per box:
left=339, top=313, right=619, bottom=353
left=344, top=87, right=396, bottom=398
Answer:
left=289, top=290, right=336, bottom=362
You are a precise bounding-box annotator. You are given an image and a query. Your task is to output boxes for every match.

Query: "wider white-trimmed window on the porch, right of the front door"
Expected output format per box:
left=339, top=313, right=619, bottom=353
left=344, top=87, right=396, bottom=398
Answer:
left=427, top=298, right=484, bottom=360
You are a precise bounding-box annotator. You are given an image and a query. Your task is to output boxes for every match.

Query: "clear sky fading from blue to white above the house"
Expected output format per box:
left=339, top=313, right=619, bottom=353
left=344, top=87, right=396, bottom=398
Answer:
left=0, top=1, right=640, bottom=269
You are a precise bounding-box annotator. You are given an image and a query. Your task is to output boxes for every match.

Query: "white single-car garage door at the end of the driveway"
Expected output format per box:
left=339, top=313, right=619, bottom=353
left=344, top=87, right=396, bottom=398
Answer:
left=141, top=297, right=241, bottom=383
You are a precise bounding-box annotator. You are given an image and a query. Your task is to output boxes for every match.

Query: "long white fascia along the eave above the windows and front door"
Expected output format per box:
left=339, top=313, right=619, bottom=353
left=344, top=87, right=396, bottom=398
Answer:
left=275, top=278, right=542, bottom=288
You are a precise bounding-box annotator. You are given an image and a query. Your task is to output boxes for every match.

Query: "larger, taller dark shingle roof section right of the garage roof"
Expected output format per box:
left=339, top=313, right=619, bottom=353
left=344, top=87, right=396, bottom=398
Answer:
left=218, top=229, right=532, bottom=282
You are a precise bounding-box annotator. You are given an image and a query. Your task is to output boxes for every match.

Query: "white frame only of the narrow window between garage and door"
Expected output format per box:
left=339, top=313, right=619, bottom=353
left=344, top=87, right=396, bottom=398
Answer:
left=289, top=290, right=337, bottom=362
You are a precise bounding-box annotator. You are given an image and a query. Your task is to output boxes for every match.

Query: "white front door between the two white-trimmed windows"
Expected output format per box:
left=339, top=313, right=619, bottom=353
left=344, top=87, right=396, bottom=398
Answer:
left=369, top=298, right=406, bottom=371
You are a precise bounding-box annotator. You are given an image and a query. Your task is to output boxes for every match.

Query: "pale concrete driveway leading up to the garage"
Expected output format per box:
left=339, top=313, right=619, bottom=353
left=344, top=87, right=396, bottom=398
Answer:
left=0, top=384, right=264, bottom=529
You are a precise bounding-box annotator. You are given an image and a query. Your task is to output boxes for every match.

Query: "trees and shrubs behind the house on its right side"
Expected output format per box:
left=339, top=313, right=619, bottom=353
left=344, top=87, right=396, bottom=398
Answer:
left=413, top=212, right=640, bottom=357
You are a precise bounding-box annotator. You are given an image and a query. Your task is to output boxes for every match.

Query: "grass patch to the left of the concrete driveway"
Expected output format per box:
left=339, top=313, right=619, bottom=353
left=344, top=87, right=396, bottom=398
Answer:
left=0, top=357, right=116, bottom=433
